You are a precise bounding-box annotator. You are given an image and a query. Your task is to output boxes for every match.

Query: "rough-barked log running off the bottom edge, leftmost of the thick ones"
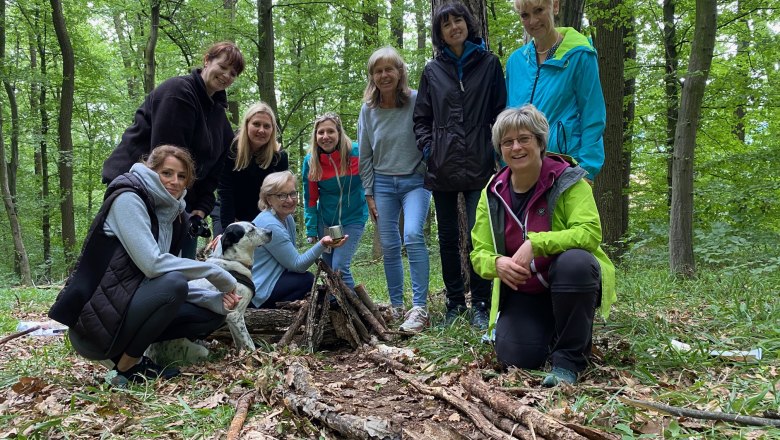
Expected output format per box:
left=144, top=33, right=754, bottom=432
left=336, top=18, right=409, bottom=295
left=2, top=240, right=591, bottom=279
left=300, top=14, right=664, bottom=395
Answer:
left=282, top=362, right=401, bottom=440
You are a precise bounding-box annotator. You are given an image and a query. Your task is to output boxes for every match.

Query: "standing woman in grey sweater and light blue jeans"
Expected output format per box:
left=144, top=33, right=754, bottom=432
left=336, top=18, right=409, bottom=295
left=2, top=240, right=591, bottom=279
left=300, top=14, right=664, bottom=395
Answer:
left=358, top=46, right=431, bottom=333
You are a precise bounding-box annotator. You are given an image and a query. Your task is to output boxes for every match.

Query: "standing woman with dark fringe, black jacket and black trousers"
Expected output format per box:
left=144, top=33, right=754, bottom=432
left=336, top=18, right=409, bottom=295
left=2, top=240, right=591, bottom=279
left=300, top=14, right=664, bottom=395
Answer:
left=414, top=3, right=506, bottom=329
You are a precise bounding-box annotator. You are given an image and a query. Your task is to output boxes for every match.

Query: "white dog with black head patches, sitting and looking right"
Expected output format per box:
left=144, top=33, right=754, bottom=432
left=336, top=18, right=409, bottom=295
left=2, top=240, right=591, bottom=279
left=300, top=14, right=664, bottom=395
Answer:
left=146, top=222, right=271, bottom=365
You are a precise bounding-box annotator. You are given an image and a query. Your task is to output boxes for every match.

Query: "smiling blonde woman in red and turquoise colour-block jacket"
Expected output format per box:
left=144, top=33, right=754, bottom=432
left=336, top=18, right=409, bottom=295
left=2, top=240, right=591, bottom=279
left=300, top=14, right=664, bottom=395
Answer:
left=303, top=113, right=368, bottom=287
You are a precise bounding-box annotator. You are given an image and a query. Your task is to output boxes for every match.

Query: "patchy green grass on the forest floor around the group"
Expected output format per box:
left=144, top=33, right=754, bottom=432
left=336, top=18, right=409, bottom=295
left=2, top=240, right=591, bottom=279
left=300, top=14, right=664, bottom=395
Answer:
left=0, top=246, right=780, bottom=439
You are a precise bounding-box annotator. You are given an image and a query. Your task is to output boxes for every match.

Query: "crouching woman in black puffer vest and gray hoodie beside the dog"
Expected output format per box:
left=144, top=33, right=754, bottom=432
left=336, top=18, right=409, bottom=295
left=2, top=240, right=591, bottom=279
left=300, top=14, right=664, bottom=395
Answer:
left=49, top=145, right=240, bottom=386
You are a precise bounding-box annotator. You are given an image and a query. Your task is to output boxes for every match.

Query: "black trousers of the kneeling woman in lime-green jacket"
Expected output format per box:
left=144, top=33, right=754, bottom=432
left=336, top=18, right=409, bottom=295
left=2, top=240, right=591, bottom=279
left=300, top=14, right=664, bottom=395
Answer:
left=495, top=249, right=601, bottom=373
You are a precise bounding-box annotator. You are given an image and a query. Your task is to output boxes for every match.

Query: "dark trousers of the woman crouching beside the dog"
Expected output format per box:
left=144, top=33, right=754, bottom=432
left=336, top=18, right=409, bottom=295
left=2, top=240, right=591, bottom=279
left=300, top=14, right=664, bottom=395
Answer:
left=68, top=272, right=225, bottom=360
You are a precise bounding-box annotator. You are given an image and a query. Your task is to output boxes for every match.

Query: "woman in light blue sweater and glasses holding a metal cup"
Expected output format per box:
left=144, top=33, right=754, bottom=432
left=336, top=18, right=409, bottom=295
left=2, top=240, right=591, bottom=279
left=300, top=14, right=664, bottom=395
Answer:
left=252, top=171, right=349, bottom=309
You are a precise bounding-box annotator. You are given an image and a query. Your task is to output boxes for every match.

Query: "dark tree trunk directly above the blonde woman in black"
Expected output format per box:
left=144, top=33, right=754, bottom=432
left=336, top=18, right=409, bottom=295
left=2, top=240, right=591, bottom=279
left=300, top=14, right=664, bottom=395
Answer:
left=257, top=0, right=279, bottom=115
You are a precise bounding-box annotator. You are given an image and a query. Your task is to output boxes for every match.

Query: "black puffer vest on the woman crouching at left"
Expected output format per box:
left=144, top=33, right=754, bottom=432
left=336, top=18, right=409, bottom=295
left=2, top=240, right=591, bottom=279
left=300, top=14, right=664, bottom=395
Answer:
left=49, top=173, right=186, bottom=353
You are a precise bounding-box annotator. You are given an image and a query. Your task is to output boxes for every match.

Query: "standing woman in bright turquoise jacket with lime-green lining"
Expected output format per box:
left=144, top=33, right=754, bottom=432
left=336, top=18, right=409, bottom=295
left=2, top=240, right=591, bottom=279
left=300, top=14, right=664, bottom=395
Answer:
left=506, top=0, right=607, bottom=181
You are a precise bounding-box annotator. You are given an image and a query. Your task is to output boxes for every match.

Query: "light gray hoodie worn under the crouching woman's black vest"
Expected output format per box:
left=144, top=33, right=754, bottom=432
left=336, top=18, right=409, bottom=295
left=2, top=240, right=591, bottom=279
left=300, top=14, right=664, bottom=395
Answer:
left=103, top=163, right=236, bottom=315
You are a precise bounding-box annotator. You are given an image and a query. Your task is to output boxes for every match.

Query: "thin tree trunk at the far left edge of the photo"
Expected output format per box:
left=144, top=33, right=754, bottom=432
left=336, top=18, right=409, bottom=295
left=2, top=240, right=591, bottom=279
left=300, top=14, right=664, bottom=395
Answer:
left=0, top=2, right=32, bottom=286
